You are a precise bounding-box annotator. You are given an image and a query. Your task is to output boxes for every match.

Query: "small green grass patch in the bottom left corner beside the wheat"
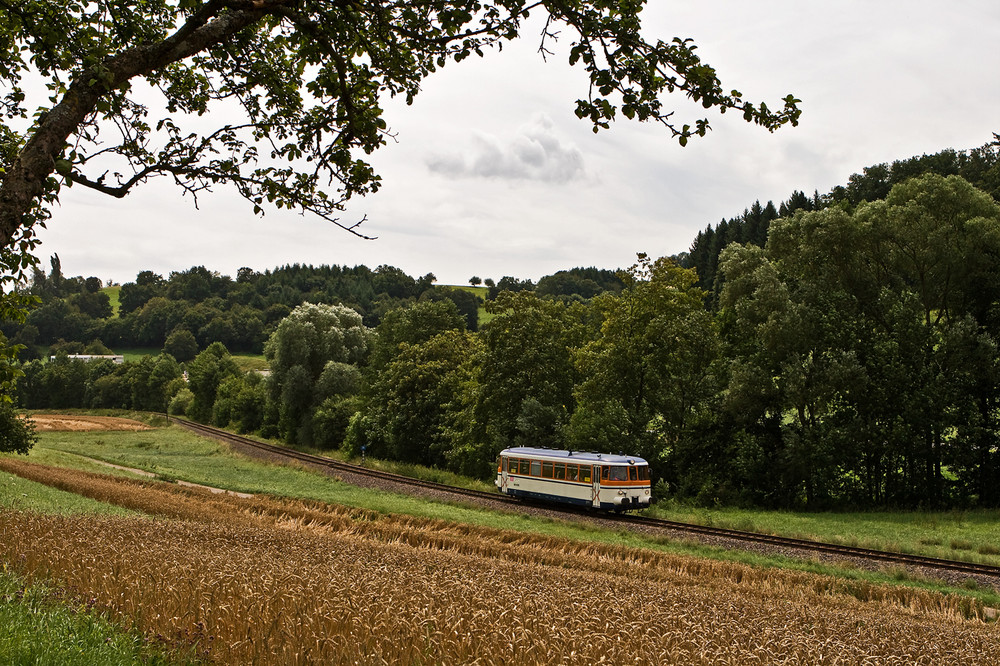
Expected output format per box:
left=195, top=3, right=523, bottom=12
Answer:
left=0, top=567, right=197, bottom=666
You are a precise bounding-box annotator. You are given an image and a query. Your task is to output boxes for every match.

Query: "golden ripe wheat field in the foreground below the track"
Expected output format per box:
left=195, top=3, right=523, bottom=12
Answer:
left=0, top=458, right=1000, bottom=664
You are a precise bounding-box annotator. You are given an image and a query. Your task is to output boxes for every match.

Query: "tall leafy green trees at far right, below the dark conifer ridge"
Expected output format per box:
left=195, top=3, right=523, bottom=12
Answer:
left=722, top=174, right=1000, bottom=506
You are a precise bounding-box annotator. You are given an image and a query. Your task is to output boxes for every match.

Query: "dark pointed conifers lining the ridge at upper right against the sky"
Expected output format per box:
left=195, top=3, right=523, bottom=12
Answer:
left=681, top=135, right=1000, bottom=307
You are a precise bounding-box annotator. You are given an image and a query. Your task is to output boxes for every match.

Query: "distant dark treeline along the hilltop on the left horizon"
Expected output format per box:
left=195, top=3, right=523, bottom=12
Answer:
left=2, top=256, right=462, bottom=361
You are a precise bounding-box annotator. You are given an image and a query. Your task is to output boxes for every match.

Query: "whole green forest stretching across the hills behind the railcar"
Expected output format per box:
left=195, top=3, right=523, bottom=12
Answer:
left=2, top=140, right=1000, bottom=510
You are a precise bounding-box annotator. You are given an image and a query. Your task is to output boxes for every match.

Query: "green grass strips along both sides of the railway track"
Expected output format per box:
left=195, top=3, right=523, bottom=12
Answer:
left=7, top=418, right=1000, bottom=607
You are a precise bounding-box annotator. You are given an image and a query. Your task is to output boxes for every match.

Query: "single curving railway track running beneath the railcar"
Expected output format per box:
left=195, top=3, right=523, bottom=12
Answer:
left=168, top=416, right=1000, bottom=580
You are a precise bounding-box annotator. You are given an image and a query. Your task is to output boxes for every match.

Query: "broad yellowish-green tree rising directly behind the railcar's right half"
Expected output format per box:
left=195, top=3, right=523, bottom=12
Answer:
left=571, top=254, right=718, bottom=474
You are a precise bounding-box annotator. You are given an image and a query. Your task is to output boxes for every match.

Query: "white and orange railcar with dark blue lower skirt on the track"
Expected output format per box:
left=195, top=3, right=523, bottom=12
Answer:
left=496, top=447, right=652, bottom=511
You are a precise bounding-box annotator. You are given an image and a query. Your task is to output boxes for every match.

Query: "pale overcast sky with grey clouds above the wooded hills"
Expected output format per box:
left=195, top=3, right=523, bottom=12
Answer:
left=33, top=0, right=1000, bottom=284
